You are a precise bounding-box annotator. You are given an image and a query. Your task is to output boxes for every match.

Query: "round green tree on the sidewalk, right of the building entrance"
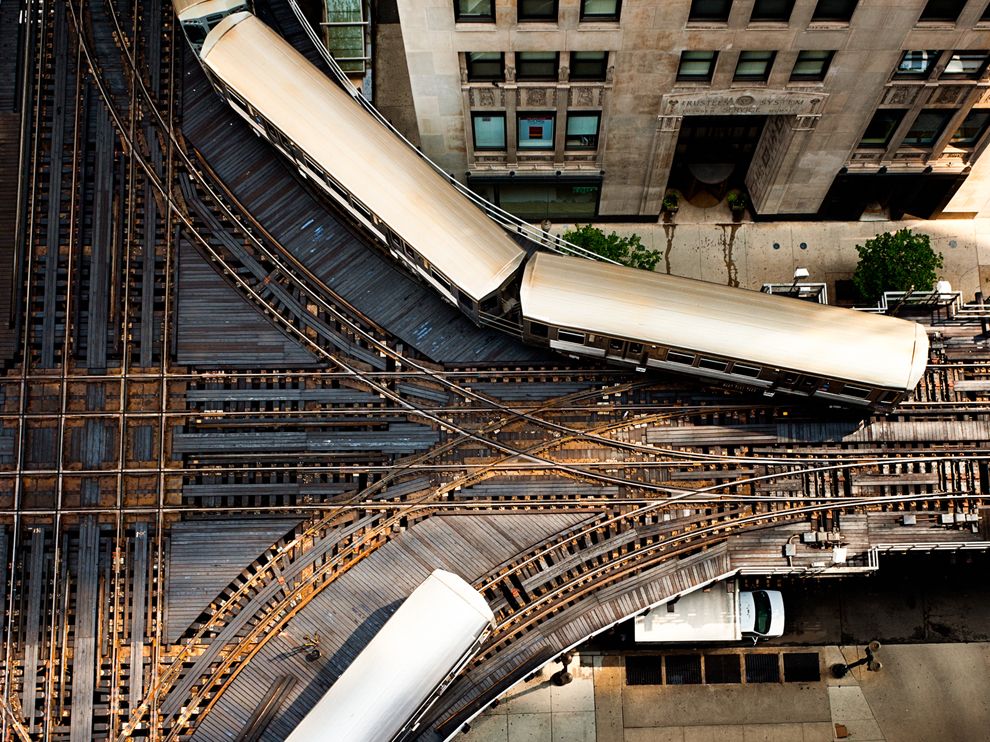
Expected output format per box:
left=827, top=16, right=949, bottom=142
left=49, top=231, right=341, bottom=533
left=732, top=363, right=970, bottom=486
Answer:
left=853, top=229, right=942, bottom=301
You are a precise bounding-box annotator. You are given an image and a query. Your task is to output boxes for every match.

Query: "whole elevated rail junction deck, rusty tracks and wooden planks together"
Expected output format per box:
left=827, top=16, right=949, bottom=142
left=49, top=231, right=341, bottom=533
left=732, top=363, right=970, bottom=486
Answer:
left=0, top=0, right=990, bottom=740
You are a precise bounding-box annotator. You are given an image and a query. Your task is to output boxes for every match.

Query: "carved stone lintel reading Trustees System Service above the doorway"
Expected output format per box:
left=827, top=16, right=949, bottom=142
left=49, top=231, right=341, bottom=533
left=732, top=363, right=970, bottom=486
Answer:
left=660, top=88, right=828, bottom=116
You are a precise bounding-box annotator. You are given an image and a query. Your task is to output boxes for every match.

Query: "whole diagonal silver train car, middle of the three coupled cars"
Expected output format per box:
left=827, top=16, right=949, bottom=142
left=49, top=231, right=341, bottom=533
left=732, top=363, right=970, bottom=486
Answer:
left=200, top=13, right=526, bottom=321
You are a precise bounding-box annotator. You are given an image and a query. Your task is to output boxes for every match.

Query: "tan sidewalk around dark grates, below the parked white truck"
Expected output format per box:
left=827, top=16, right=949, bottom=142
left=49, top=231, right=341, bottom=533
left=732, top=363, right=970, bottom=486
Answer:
left=456, top=643, right=990, bottom=742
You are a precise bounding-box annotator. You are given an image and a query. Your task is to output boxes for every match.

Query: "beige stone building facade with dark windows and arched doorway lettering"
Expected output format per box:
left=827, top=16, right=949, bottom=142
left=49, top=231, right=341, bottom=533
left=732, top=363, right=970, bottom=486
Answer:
left=388, top=0, right=990, bottom=220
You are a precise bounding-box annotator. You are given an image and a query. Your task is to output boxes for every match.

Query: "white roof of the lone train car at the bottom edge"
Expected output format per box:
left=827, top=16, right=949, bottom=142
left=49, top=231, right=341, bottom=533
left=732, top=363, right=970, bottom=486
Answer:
left=286, top=569, right=494, bottom=742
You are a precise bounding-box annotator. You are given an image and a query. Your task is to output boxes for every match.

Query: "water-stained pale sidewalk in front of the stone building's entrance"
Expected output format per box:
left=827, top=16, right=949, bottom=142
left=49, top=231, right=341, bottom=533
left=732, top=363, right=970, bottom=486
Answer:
left=552, top=200, right=990, bottom=303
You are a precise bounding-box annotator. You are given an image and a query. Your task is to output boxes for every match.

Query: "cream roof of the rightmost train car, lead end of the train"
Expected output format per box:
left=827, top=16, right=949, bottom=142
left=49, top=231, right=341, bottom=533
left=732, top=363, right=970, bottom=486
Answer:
left=520, top=253, right=928, bottom=390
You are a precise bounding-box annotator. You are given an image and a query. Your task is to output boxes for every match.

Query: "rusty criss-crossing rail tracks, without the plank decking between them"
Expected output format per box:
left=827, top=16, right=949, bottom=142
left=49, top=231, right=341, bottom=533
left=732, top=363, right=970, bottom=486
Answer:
left=0, top=0, right=990, bottom=739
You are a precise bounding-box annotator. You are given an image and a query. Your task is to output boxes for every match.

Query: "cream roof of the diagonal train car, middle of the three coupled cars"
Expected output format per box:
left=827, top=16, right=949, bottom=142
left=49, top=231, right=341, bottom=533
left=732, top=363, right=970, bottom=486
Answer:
left=202, top=13, right=526, bottom=300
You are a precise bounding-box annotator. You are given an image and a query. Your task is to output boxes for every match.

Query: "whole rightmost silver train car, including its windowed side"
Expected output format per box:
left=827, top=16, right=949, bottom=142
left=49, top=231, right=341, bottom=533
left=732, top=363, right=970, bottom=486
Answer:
left=520, top=253, right=928, bottom=406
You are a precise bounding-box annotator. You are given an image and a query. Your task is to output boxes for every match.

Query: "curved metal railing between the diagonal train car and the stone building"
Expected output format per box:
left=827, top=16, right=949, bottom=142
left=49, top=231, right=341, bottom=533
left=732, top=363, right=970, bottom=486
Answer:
left=288, top=0, right=620, bottom=265
